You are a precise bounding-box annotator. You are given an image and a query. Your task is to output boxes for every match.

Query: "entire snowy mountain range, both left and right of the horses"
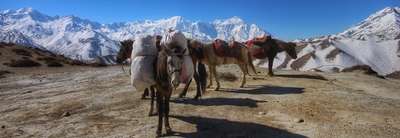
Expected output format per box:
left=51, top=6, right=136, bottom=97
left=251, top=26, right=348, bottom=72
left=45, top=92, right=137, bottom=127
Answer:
left=0, top=7, right=400, bottom=75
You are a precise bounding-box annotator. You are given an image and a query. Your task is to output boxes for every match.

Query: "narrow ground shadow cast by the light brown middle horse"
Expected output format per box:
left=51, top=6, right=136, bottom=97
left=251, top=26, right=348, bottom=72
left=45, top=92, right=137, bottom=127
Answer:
left=221, top=85, right=304, bottom=95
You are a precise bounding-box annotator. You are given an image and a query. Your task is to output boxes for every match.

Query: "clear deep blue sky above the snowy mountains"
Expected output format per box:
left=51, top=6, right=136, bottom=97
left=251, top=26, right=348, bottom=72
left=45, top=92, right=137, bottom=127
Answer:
left=0, top=0, right=400, bottom=40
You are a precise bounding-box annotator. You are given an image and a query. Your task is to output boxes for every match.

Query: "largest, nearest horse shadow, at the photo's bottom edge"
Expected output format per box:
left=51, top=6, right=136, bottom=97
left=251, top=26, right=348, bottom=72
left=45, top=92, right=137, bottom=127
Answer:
left=170, top=115, right=306, bottom=138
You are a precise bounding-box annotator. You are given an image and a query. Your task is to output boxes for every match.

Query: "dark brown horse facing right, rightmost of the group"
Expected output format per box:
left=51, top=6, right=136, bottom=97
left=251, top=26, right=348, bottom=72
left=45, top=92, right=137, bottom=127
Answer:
left=246, top=36, right=297, bottom=76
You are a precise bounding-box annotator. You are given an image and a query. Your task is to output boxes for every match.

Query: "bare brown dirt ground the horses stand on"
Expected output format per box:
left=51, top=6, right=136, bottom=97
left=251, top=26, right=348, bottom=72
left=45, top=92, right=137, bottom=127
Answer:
left=0, top=67, right=400, bottom=138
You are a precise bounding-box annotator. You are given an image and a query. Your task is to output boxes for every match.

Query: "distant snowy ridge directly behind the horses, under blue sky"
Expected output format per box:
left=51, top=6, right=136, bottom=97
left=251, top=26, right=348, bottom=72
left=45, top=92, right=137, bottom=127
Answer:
left=101, top=16, right=267, bottom=41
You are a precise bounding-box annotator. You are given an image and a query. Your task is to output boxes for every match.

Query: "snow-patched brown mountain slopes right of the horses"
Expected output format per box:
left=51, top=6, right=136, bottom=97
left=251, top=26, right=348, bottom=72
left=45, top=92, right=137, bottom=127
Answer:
left=266, top=7, right=400, bottom=75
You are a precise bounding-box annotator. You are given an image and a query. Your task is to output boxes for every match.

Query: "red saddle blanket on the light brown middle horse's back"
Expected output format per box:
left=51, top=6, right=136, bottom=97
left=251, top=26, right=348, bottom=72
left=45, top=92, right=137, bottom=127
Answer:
left=213, top=39, right=240, bottom=58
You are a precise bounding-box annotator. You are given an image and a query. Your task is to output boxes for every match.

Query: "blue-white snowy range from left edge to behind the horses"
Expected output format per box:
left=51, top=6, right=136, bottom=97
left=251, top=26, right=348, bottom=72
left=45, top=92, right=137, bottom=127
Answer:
left=0, top=8, right=266, bottom=60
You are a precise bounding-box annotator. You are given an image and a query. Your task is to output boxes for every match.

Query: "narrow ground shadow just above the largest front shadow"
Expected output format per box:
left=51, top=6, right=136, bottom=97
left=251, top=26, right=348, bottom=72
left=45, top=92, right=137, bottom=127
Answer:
left=171, top=97, right=267, bottom=108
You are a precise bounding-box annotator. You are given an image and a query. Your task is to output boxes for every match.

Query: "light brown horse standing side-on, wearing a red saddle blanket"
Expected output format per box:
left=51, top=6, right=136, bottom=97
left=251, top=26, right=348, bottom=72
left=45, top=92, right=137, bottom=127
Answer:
left=188, top=40, right=256, bottom=90
